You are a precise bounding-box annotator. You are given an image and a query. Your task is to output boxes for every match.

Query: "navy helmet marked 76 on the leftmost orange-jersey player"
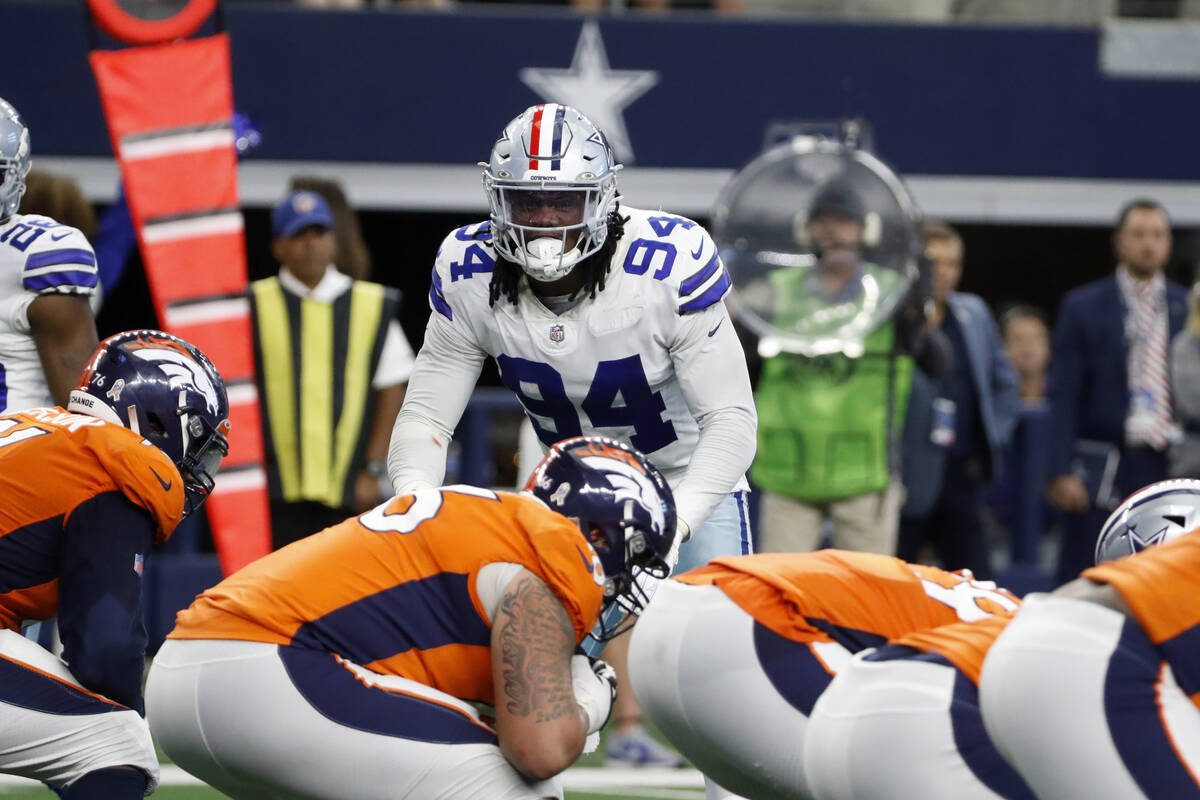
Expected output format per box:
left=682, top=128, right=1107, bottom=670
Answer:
left=67, top=330, right=229, bottom=517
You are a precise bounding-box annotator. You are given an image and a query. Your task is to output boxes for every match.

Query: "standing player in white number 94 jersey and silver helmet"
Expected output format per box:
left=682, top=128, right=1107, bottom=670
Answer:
left=388, top=103, right=757, bottom=786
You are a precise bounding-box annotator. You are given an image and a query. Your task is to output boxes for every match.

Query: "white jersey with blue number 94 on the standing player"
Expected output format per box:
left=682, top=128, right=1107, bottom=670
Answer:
left=410, top=207, right=754, bottom=482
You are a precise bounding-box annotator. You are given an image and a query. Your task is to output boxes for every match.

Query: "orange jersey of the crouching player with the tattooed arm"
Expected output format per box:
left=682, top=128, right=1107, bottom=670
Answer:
left=169, top=487, right=604, bottom=704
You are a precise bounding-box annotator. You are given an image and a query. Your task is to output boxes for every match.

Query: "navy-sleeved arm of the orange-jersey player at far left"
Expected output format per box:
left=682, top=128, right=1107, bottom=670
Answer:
left=59, top=492, right=155, bottom=714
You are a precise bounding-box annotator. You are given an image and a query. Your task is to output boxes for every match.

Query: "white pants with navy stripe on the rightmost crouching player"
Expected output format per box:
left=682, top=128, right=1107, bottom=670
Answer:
left=979, top=595, right=1200, bottom=800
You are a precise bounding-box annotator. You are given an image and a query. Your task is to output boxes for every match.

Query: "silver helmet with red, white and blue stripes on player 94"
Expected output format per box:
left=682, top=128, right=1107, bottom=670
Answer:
left=480, top=103, right=620, bottom=281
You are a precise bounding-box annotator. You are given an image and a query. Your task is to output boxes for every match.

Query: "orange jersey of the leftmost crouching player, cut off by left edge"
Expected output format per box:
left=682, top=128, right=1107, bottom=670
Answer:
left=0, top=408, right=184, bottom=631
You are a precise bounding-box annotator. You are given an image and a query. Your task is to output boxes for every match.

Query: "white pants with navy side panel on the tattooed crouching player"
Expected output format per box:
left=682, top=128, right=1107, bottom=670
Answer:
left=146, top=639, right=563, bottom=800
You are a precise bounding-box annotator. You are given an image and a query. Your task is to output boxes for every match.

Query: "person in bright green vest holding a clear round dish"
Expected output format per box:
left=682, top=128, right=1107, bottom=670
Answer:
left=714, top=137, right=949, bottom=555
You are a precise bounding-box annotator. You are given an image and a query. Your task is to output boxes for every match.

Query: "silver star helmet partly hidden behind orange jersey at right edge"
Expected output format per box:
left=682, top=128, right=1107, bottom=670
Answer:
left=1096, top=479, right=1200, bottom=564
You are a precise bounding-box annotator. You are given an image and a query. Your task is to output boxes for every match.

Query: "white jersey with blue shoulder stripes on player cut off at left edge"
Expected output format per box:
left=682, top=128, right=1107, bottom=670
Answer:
left=0, top=213, right=96, bottom=411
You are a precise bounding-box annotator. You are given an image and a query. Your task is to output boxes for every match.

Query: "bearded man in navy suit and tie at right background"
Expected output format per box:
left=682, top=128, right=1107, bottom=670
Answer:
left=1048, top=198, right=1187, bottom=583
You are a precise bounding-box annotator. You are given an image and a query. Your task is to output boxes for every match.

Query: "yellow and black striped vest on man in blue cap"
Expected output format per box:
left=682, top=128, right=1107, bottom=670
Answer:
left=250, top=277, right=400, bottom=509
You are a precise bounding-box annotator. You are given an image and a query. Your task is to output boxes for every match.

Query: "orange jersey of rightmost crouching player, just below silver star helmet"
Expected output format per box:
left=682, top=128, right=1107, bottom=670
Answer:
left=1081, top=530, right=1200, bottom=644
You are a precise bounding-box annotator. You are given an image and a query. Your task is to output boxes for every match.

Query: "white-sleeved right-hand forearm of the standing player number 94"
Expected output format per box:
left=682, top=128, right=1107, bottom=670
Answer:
left=674, top=405, right=758, bottom=531
